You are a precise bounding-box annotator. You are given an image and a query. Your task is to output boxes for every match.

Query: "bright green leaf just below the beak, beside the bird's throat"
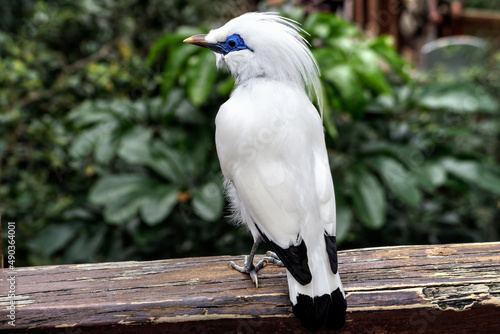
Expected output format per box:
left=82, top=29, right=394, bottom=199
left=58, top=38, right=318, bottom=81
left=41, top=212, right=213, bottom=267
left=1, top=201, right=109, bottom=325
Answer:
left=187, top=52, right=217, bottom=106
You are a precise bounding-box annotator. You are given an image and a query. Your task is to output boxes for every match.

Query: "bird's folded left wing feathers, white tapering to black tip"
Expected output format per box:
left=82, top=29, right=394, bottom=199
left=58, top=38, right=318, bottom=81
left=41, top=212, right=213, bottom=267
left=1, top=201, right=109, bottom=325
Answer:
left=233, top=150, right=312, bottom=284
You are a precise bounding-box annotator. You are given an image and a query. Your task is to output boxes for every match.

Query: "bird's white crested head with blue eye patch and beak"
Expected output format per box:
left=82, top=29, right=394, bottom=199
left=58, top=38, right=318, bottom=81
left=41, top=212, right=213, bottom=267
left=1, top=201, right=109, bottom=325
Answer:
left=184, top=13, right=321, bottom=110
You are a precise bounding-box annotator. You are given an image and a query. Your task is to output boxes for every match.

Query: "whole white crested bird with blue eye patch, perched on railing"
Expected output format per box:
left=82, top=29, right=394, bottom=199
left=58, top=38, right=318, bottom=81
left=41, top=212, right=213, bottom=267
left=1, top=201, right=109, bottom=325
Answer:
left=184, top=12, right=347, bottom=331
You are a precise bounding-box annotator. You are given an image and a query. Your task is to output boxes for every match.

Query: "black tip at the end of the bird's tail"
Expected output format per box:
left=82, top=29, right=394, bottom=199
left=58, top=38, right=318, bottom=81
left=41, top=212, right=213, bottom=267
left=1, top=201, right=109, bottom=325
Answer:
left=292, top=288, right=347, bottom=332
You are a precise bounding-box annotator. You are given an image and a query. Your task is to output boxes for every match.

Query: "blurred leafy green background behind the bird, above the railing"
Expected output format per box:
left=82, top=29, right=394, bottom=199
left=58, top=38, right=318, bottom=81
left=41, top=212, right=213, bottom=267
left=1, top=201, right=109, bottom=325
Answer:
left=0, top=0, right=500, bottom=266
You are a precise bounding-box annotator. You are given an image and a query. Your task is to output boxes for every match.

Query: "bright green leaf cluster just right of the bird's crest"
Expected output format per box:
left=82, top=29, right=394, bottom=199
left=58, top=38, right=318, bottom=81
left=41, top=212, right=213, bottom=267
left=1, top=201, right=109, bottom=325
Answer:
left=304, top=14, right=411, bottom=133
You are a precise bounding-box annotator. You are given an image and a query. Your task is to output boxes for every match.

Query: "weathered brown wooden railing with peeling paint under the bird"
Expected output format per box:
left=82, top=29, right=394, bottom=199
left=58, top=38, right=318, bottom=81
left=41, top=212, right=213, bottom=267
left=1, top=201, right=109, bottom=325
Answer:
left=0, top=242, right=500, bottom=333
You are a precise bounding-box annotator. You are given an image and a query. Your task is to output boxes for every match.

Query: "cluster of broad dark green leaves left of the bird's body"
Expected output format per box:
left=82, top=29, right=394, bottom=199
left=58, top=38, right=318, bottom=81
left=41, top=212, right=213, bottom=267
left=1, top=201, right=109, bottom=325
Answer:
left=70, top=94, right=224, bottom=226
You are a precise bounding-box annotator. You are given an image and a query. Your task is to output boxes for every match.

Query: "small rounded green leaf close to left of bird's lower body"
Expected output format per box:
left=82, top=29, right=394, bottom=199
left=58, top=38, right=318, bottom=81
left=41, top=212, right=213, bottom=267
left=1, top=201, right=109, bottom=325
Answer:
left=191, top=182, right=224, bottom=222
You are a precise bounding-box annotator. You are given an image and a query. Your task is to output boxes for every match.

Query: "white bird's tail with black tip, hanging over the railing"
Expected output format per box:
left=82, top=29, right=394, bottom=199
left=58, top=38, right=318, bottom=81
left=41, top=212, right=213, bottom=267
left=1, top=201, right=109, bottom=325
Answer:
left=287, top=236, right=347, bottom=332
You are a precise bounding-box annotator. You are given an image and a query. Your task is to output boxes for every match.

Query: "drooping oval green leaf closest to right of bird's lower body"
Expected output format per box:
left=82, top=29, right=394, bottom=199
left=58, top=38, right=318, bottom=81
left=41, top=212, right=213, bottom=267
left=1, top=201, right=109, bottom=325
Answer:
left=352, top=165, right=386, bottom=229
